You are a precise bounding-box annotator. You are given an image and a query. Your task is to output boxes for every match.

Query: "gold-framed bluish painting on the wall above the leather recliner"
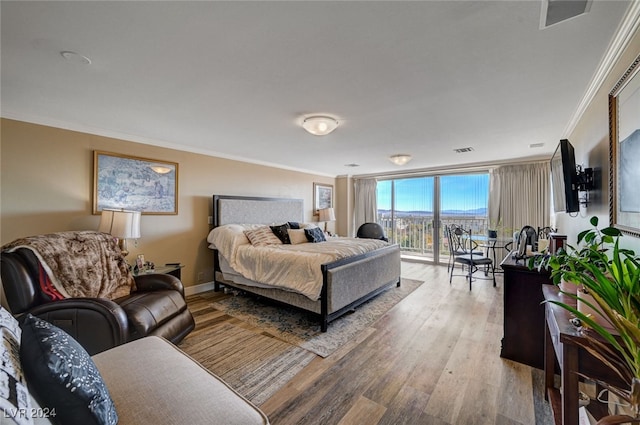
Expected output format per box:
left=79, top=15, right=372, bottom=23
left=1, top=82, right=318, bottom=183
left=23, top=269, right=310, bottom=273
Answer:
left=93, top=151, right=178, bottom=214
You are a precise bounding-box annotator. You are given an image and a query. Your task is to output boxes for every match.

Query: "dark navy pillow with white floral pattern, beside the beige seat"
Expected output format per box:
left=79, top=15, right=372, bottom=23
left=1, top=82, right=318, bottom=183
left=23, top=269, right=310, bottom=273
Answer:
left=20, top=314, right=118, bottom=425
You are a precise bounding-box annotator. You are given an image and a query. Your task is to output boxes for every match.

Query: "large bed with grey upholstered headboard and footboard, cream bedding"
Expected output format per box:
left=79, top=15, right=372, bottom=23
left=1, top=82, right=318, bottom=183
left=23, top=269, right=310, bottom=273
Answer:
left=207, top=195, right=400, bottom=332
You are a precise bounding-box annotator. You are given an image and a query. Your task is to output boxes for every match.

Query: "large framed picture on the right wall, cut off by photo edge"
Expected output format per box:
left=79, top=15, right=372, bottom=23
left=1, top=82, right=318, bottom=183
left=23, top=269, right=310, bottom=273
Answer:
left=609, top=56, right=640, bottom=237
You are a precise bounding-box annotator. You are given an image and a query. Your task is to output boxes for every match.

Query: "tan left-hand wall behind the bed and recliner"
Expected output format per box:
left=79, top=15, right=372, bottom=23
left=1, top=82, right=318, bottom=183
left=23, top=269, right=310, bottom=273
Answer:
left=0, top=119, right=342, bottom=286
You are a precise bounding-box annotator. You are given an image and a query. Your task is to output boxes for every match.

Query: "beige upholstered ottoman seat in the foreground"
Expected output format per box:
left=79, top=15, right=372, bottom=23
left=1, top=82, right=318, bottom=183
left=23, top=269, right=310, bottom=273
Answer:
left=92, top=336, right=269, bottom=425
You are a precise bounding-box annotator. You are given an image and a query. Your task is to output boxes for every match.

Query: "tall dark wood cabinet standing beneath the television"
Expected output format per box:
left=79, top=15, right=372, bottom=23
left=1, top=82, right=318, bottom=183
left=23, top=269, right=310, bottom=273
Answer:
left=500, top=254, right=552, bottom=369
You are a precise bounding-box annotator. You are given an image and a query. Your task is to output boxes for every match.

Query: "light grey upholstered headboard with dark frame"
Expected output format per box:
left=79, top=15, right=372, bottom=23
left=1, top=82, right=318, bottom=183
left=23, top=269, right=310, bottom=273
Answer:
left=213, top=195, right=304, bottom=227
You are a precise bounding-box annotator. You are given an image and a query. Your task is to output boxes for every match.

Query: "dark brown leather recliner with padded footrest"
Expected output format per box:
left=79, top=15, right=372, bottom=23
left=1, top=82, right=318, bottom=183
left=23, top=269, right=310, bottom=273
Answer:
left=0, top=238, right=195, bottom=355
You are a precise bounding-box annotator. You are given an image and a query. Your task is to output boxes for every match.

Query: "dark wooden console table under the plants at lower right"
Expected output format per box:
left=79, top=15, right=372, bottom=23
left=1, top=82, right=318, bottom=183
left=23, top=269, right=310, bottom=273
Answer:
left=543, top=285, right=628, bottom=425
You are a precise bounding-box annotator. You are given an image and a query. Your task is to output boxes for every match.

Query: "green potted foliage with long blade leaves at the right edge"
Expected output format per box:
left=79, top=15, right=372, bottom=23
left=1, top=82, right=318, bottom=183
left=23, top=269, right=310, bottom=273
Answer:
left=544, top=217, right=640, bottom=424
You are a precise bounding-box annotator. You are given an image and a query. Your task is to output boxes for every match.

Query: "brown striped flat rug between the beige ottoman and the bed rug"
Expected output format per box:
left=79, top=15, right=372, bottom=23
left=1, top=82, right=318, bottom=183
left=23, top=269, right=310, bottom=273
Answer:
left=179, top=323, right=316, bottom=406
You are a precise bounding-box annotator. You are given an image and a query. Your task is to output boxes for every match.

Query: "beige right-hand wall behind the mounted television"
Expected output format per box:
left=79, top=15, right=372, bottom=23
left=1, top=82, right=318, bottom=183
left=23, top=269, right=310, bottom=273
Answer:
left=555, top=32, right=640, bottom=252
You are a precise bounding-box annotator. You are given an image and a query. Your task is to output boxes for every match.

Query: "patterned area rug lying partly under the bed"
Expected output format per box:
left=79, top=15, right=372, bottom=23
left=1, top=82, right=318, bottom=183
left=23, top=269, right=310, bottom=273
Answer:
left=212, top=278, right=423, bottom=357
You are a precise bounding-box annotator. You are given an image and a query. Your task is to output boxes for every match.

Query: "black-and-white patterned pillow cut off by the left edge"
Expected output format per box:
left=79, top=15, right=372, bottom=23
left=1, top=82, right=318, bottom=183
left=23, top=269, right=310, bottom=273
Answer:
left=0, top=307, right=34, bottom=425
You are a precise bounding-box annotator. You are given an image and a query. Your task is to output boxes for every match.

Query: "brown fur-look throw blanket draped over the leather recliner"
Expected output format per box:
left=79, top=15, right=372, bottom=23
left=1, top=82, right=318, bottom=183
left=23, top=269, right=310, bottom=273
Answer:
left=2, top=230, right=135, bottom=300
